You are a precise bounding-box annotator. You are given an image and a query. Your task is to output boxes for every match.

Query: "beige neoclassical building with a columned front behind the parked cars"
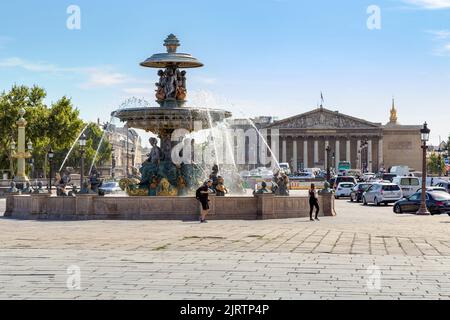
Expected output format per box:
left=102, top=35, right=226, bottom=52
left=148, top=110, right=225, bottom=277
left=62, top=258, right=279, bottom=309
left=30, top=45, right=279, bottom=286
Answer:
left=230, top=101, right=422, bottom=172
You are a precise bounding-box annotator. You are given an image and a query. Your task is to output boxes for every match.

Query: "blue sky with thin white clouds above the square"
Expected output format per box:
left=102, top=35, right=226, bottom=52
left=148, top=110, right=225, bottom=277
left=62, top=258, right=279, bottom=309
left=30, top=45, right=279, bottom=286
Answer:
left=0, top=0, right=450, bottom=143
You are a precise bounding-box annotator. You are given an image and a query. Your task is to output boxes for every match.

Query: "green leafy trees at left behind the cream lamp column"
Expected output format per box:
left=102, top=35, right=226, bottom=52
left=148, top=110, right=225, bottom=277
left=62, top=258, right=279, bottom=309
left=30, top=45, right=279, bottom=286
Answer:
left=0, top=85, right=111, bottom=176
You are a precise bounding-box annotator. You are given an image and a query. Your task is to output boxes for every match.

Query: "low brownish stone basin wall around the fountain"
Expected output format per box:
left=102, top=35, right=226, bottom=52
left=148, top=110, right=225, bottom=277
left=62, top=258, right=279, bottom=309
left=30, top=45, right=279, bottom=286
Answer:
left=4, top=194, right=336, bottom=221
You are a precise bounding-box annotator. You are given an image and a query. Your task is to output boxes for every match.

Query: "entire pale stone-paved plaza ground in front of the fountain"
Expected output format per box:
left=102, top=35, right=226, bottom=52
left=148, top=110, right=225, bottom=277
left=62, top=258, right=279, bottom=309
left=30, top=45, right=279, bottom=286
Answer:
left=0, top=200, right=450, bottom=299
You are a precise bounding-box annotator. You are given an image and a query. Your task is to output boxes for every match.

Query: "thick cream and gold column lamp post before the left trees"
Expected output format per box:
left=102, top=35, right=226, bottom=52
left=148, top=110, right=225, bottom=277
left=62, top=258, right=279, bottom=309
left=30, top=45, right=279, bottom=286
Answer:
left=11, top=108, right=32, bottom=186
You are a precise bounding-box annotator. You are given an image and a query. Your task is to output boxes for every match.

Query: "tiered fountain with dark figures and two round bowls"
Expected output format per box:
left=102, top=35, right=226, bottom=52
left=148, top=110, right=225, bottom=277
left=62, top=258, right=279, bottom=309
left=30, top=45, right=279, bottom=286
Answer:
left=112, top=34, right=231, bottom=196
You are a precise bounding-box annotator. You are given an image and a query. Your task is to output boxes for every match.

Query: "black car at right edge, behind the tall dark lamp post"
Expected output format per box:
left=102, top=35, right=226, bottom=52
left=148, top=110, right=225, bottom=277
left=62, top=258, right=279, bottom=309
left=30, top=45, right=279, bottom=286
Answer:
left=393, top=191, right=450, bottom=216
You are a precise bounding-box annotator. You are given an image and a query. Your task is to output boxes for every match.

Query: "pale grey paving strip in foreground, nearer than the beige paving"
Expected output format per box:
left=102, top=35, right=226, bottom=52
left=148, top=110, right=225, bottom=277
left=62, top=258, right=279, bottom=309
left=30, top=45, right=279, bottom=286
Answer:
left=0, top=249, right=450, bottom=299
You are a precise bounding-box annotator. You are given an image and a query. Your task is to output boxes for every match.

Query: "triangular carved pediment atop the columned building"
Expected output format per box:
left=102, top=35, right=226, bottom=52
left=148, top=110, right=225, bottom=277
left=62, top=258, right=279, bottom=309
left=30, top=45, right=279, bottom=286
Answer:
left=267, top=108, right=381, bottom=129
